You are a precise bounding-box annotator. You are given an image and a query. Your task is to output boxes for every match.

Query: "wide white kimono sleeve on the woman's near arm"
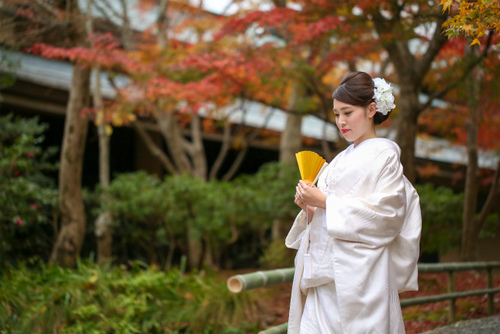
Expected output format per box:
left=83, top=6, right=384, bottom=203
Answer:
left=326, top=150, right=406, bottom=248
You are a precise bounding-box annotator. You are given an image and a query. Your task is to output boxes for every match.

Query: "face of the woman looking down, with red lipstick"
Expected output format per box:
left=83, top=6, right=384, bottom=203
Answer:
left=333, top=100, right=376, bottom=146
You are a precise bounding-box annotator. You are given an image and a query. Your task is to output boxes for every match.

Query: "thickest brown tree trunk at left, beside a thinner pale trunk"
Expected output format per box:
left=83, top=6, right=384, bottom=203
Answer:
left=50, top=65, right=90, bottom=267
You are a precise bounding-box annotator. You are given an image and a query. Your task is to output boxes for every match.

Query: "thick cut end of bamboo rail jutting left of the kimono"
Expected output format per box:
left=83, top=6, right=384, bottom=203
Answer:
left=227, top=268, right=295, bottom=293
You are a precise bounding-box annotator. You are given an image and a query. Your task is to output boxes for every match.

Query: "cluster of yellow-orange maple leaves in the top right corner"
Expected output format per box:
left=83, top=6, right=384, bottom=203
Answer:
left=440, top=0, right=500, bottom=45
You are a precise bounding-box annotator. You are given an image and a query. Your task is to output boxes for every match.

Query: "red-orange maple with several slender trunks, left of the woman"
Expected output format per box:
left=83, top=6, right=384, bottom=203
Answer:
left=25, top=1, right=288, bottom=267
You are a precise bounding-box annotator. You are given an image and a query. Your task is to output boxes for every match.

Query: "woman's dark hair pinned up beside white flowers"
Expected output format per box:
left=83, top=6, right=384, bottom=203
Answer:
left=332, top=72, right=390, bottom=125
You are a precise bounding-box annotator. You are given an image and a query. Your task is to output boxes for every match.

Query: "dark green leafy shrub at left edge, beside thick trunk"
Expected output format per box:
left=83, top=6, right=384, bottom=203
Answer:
left=0, top=114, right=57, bottom=264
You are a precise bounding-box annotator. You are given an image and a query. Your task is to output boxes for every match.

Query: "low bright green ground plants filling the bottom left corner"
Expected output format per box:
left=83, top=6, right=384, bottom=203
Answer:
left=0, top=262, right=255, bottom=334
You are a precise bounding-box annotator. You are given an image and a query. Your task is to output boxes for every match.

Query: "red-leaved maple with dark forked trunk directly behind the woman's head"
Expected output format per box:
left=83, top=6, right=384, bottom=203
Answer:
left=215, top=1, right=492, bottom=185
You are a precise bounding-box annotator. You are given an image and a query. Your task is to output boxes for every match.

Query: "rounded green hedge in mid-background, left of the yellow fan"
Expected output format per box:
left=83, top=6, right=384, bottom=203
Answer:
left=101, top=163, right=298, bottom=267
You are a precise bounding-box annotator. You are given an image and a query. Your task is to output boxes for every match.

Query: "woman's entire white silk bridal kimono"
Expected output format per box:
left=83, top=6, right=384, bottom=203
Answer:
left=286, top=138, right=422, bottom=334
